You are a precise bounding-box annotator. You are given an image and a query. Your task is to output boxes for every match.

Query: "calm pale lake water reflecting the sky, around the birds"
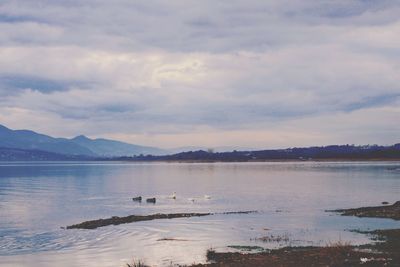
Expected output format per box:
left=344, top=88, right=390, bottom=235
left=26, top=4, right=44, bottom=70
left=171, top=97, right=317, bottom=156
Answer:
left=0, top=162, right=400, bottom=267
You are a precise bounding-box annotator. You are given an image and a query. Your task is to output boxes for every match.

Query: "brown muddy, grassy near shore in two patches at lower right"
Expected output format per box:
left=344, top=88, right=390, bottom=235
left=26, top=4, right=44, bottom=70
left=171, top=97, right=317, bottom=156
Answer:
left=190, top=201, right=400, bottom=267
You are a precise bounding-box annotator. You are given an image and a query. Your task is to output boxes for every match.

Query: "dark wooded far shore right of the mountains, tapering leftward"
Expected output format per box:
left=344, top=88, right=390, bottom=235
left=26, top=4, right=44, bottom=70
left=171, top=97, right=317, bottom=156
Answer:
left=113, top=144, right=400, bottom=162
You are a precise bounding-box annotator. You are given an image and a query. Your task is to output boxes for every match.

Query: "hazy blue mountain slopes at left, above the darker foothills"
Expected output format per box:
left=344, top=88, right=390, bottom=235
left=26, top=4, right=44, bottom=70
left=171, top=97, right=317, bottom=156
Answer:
left=0, top=125, right=168, bottom=158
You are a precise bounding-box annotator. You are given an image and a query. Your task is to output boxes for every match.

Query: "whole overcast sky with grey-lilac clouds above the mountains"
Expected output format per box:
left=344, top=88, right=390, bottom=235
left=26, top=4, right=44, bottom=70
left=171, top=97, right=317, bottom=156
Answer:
left=0, top=0, right=400, bottom=148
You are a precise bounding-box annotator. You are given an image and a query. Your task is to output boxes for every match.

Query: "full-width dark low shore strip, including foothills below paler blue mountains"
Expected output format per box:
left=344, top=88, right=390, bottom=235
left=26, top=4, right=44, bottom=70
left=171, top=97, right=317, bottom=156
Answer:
left=0, top=144, right=400, bottom=162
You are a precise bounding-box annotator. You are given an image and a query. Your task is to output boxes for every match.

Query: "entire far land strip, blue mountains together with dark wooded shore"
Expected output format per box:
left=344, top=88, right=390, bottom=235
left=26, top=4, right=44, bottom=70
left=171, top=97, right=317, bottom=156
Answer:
left=0, top=125, right=400, bottom=161
